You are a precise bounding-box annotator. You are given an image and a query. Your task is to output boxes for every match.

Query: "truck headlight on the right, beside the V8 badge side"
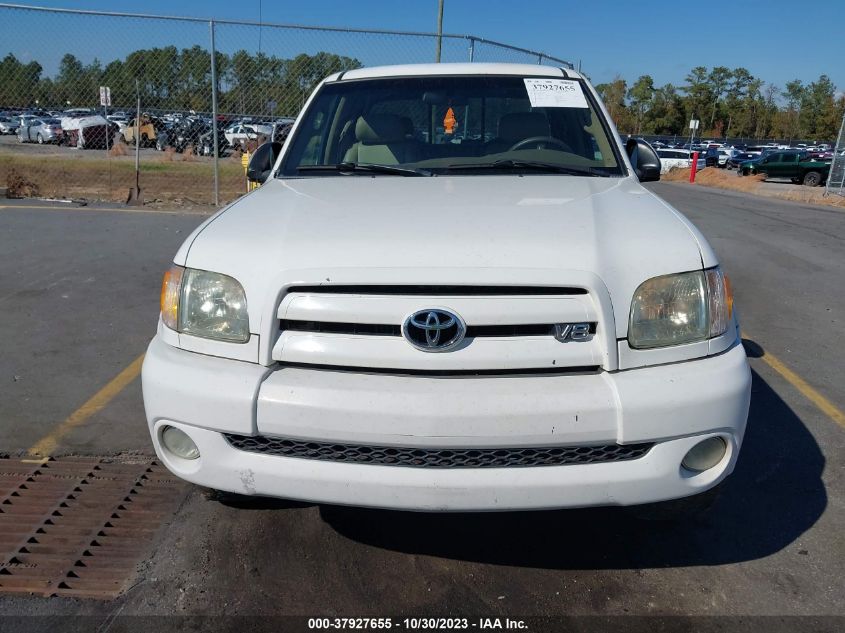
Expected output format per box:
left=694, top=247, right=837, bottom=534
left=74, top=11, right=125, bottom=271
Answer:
left=628, top=268, right=733, bottom=349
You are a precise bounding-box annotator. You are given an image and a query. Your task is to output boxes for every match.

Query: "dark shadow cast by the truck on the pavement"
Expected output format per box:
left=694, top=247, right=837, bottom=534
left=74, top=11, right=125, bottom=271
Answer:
left=320, top=350, right=827, bottom=569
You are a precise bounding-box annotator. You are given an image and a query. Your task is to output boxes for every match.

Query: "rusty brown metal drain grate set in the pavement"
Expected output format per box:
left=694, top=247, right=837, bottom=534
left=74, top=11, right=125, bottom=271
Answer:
left=0, top=457, right=185, bottom=598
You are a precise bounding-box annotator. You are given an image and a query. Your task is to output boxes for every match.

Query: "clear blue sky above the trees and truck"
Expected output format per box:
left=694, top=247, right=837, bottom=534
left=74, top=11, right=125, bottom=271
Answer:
left=6, top=0, right=845, bottom=91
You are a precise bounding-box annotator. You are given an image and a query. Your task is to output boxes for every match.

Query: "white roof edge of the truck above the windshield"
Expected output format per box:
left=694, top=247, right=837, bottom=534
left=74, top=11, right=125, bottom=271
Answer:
left=326, top=63, right=581, bottom=81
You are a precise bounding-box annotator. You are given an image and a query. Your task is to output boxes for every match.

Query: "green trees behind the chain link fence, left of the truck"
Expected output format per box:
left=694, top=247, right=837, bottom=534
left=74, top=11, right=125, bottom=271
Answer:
left=0, top=46, right=361, bottom=116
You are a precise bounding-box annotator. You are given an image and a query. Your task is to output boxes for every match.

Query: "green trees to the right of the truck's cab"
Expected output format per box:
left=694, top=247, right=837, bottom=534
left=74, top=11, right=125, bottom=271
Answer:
left=596, top=66, right=845, bottom=141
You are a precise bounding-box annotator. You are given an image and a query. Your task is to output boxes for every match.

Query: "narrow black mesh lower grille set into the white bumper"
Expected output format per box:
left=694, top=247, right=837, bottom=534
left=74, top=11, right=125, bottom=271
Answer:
left=224, top=433, right=654, bottom=468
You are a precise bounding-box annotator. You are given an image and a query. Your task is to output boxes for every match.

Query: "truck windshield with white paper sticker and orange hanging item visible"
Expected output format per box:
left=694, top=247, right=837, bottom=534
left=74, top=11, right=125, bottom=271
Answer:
left=279, top=75, right=623, bottom=177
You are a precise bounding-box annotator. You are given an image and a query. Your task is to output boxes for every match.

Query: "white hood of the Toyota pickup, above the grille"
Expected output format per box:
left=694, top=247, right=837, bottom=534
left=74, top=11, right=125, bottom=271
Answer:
left=181, top=174, right=716, bottom=337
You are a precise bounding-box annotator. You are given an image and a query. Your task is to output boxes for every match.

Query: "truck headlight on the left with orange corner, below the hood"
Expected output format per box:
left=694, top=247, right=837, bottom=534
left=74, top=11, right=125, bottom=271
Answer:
left=161, top=266, right=249, bottom=343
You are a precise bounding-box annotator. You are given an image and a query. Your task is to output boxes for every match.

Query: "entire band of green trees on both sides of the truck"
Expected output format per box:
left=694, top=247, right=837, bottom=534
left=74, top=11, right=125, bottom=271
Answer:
left=0, top=52, right=845, bottom=140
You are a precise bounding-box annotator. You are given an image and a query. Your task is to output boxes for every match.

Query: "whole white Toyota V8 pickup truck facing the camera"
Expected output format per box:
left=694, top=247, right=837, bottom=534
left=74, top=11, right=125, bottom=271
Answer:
left=143, top=64, right=751, bottom=511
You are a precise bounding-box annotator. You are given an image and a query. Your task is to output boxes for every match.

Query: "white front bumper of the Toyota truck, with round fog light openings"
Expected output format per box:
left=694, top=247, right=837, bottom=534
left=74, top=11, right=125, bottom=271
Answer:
left=143, top=337, right=751, bottom=511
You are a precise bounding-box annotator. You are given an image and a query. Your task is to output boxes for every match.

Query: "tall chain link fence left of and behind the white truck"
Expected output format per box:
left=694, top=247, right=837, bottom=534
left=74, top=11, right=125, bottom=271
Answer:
left=0, top=3, right=571, bottom=205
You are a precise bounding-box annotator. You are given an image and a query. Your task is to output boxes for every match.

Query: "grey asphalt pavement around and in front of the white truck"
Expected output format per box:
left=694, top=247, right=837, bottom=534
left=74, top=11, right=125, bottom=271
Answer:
left=0, top=183, right=845, bottom=630
